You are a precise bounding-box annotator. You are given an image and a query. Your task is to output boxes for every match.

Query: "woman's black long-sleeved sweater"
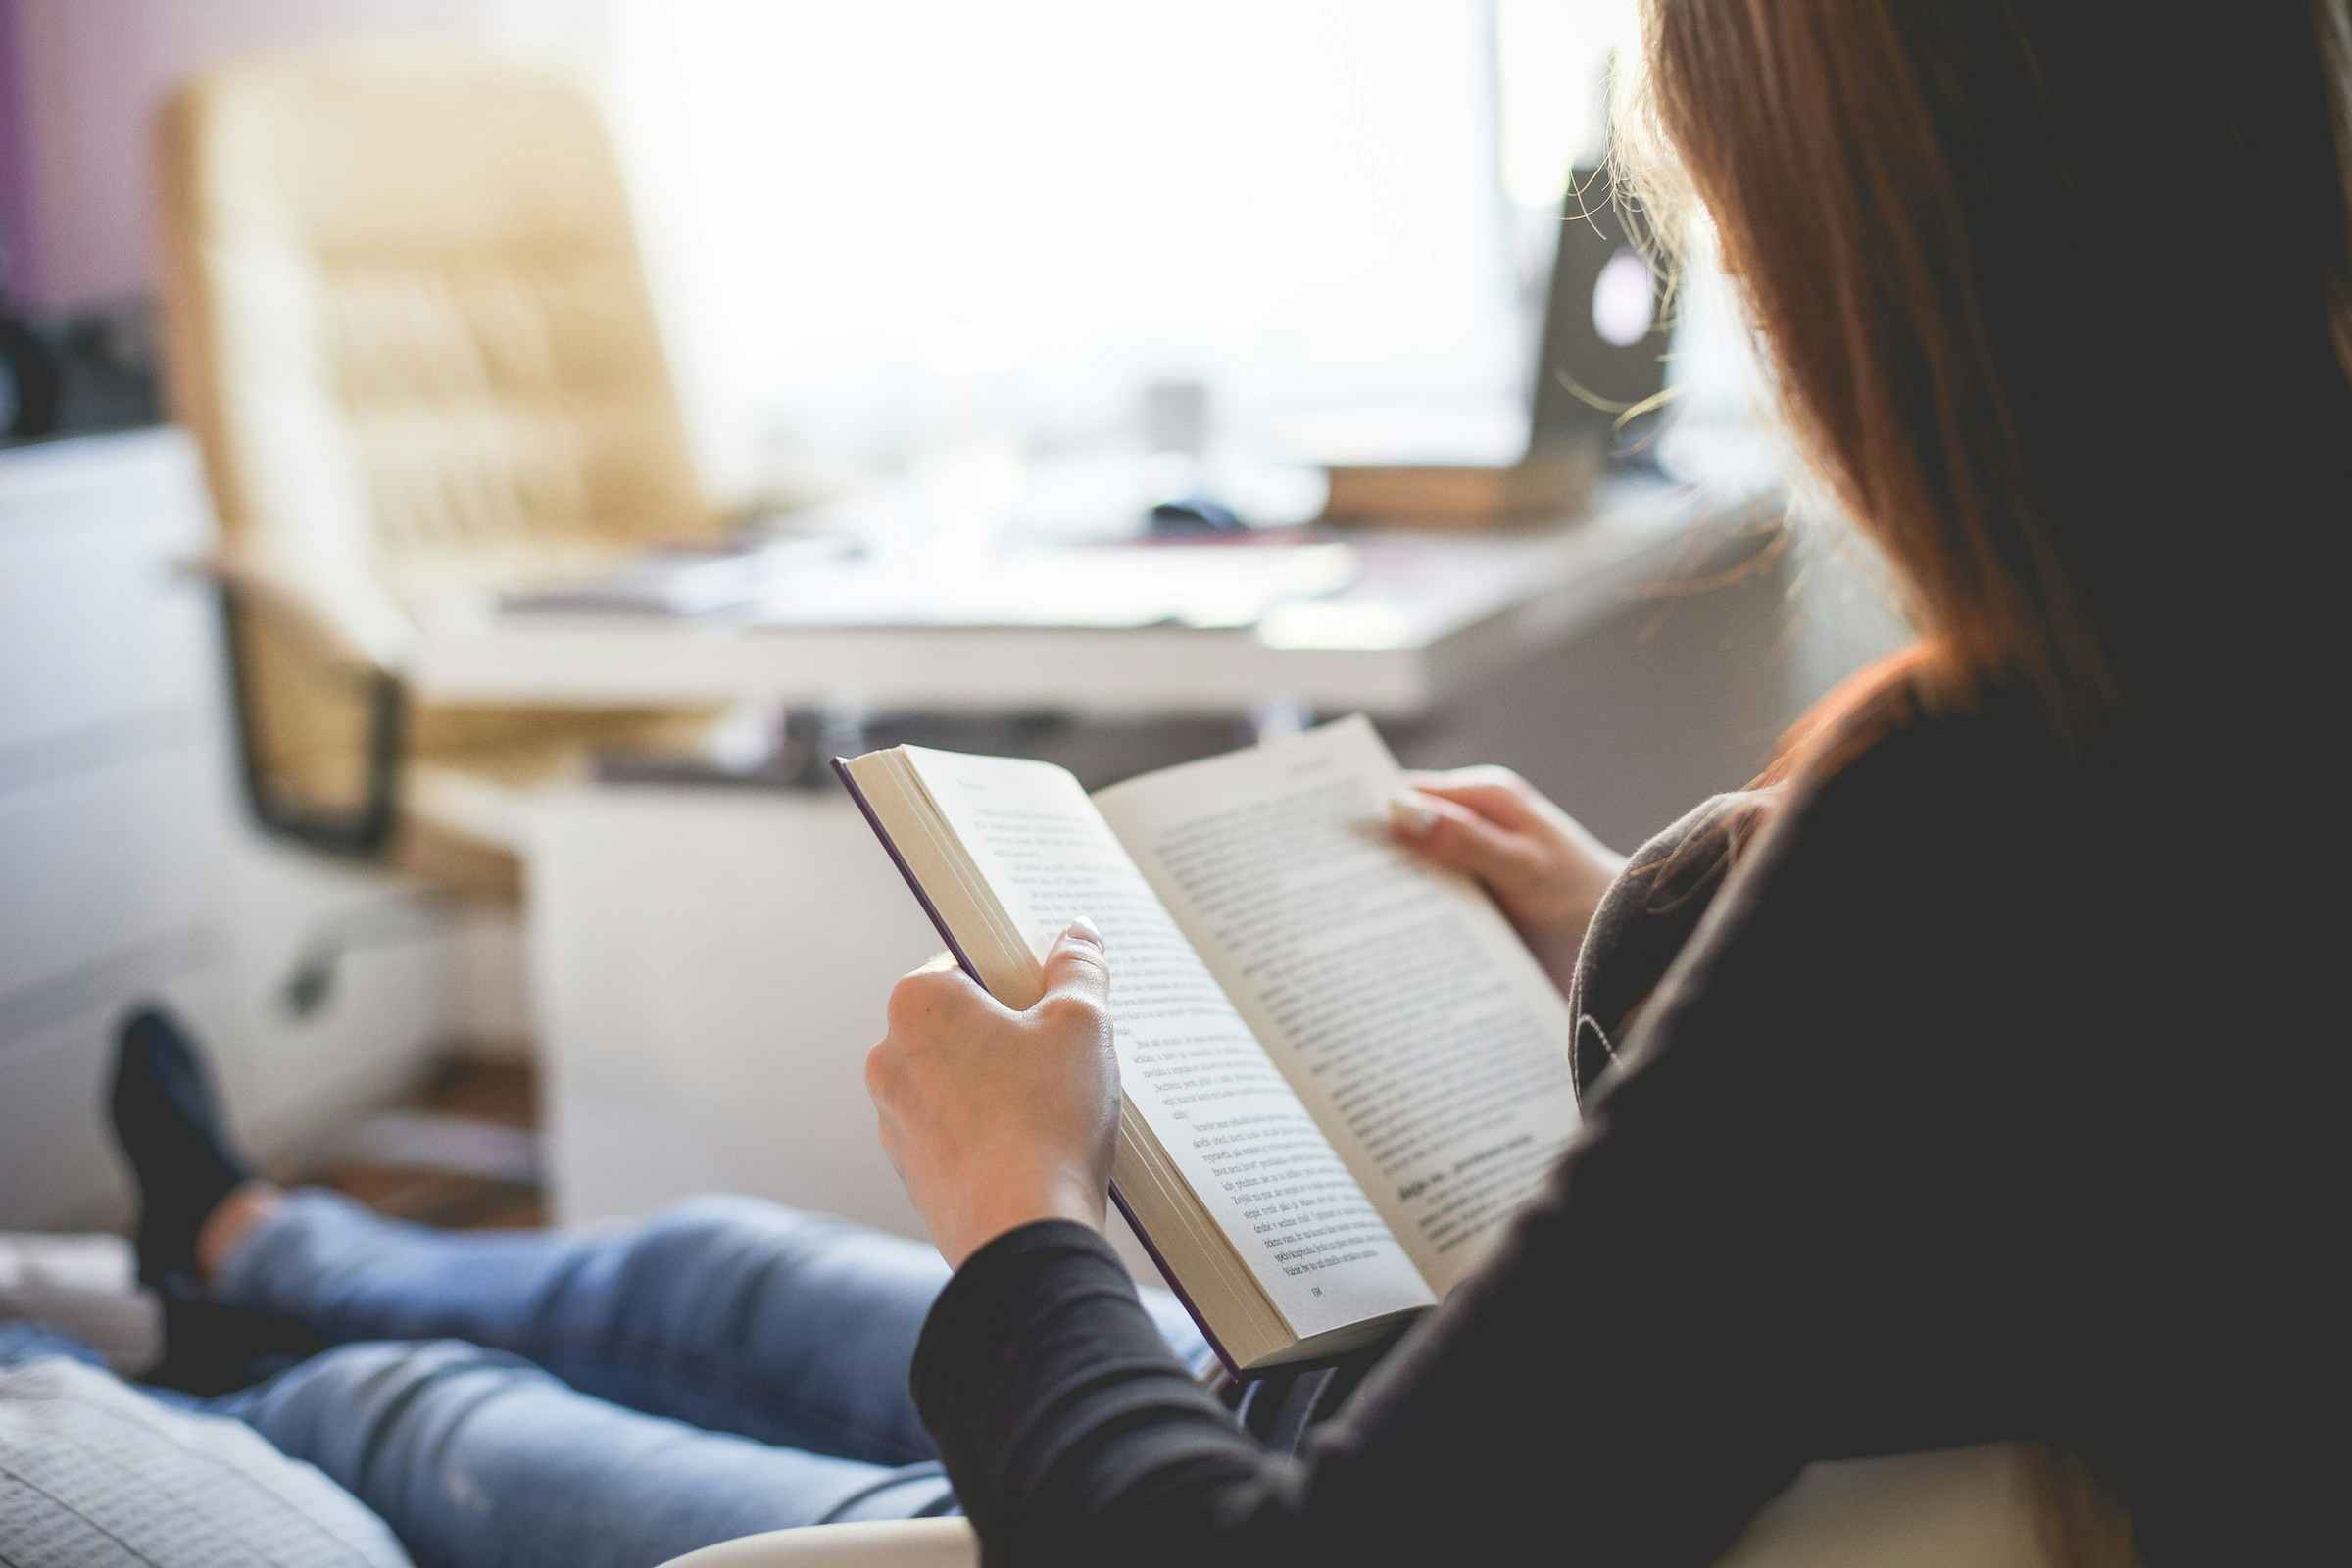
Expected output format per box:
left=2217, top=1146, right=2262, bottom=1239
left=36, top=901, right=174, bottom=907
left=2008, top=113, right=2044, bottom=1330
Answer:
left=915, top=712, right=2300, bottom=1568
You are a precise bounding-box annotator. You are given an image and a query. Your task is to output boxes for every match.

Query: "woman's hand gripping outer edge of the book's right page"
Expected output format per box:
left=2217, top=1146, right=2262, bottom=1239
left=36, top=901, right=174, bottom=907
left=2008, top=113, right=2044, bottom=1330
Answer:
left=1388, top=766, right=1625, bottom=995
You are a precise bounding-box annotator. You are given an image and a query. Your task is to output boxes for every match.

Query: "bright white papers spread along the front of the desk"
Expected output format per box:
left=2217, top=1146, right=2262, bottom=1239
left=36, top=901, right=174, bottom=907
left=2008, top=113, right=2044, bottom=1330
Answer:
left=751, top=546, right=1357, bottom=630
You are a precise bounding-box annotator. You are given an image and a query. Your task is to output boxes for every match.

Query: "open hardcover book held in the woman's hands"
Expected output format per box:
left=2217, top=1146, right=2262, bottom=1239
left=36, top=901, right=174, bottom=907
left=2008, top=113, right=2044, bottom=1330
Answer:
left=835, top=717, right=1576, bottom=1373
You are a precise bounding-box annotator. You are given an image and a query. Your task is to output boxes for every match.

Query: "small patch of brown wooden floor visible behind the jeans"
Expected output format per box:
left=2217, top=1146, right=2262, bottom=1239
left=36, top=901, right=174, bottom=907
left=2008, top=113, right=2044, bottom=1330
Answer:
left=299, top=1060, right=546, bottom=1230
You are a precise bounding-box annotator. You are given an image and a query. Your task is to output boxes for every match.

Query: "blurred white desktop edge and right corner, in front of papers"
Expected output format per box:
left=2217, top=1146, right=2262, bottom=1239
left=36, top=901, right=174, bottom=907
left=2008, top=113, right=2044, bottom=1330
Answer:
left=405, top=484, right=1771, bottom=714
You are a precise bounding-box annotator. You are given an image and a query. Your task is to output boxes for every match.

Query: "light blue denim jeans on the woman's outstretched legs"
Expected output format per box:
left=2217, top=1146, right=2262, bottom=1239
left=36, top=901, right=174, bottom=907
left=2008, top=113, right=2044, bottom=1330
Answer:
left=36, top=1192, right=1209, bottom=1568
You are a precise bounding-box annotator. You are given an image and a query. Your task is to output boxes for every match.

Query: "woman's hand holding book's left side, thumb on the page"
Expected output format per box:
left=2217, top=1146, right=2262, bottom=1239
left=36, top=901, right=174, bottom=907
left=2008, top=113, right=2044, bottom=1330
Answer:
left=865, top=921, right=1119, bottom=1267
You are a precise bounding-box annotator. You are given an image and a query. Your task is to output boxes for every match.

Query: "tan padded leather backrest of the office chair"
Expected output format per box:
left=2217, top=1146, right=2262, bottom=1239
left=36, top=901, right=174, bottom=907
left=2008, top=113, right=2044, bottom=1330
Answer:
left=158, top=45, right=715, bottom=620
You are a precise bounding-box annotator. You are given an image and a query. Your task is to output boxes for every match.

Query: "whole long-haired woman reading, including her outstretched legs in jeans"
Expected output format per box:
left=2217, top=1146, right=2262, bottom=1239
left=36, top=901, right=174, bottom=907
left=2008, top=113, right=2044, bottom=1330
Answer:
left=0, top=0, right=2352, bottom=1568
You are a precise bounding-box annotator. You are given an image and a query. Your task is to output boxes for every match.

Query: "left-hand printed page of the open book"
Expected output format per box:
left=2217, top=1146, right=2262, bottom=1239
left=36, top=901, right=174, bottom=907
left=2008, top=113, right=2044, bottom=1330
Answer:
left=906, top=745, right=1433, bottom=1338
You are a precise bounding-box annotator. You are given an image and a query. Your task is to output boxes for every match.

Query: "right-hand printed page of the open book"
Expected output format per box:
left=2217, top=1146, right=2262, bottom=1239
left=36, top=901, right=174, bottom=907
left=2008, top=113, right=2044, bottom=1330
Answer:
left=1096, top=719, right=1576, bottom=1293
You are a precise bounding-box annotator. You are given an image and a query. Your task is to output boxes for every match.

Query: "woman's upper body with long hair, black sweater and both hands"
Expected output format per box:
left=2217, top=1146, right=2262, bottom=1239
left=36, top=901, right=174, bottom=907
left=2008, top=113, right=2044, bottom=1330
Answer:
left=870, top=0, right=2352, bottom=1563
